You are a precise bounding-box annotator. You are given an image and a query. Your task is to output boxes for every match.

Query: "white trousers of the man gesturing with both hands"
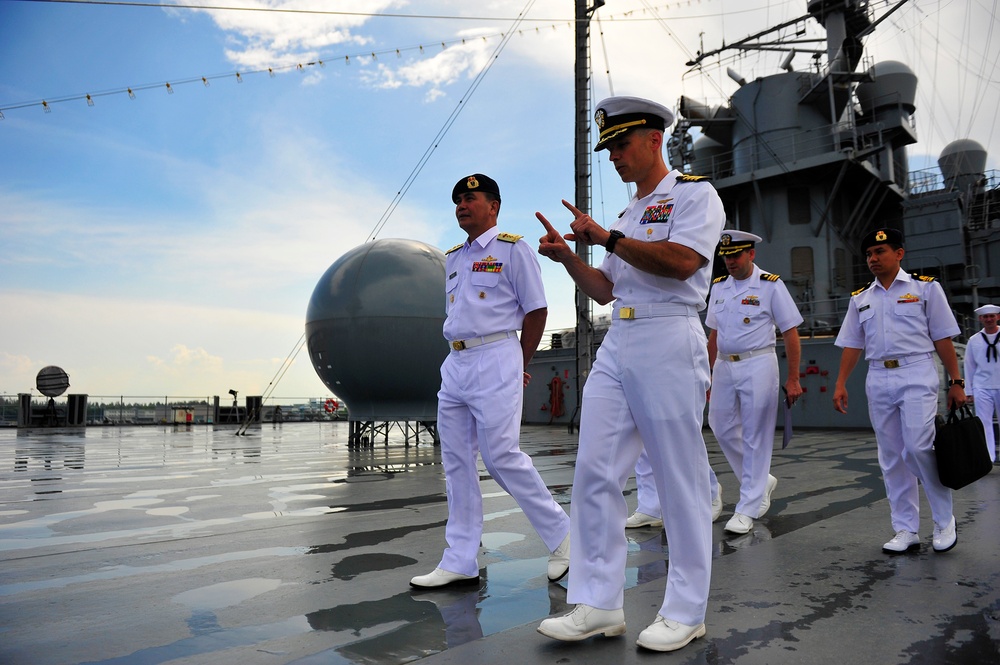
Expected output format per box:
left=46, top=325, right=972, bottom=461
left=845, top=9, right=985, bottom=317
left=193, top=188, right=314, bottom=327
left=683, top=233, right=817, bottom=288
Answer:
left=567, top=316, right=712, bottom=625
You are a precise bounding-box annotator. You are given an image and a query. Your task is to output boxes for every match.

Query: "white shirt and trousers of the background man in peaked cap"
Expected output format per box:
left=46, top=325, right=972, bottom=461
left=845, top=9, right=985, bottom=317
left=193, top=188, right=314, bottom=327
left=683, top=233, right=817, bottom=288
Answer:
left=705, top=265, right=802, bottom=518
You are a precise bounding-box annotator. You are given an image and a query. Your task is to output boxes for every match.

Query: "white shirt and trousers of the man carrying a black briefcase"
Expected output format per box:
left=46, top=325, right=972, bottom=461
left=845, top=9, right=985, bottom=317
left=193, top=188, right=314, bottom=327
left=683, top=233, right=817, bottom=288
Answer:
left=836, top=270, right=959, bottom=533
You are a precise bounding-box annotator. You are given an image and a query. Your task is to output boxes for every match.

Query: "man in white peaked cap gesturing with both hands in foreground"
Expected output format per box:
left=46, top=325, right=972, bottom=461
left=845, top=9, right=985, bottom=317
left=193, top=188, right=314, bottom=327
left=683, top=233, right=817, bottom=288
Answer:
left=536, top=97, right=725, bottom=651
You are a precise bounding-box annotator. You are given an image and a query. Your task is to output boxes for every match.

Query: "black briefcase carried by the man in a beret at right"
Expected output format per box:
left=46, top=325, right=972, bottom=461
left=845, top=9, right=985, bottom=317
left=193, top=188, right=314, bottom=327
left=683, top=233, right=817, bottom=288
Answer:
left=934, top=406, right=993, bottom=490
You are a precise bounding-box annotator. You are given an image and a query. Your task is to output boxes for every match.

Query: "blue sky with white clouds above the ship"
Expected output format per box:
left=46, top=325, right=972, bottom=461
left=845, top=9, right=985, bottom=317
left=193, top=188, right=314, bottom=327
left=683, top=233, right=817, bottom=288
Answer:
left=0, top=0, right=1000, bottom=398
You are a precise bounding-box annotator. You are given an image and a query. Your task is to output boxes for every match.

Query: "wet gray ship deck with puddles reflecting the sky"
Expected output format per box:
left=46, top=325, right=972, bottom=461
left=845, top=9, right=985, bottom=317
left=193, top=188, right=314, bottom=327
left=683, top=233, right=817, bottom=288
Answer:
left=0, top=423, right=1000, bottom=665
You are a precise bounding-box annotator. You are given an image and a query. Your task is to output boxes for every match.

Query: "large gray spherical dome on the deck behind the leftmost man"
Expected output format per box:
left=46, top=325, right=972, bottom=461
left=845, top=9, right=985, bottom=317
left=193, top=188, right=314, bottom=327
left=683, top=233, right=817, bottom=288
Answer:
left=306, top=239, right=448, bottom=421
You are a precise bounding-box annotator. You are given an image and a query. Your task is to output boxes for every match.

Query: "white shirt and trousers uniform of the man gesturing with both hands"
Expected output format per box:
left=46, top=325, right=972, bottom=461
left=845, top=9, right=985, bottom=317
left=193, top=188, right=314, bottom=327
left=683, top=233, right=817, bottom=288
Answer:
left=567, top=170, right=725, bottom=625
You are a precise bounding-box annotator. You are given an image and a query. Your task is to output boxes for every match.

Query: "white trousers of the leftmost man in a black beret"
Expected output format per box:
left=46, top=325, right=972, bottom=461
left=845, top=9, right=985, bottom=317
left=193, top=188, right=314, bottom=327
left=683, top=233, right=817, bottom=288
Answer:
left=437, top=338, right=569, bottom=575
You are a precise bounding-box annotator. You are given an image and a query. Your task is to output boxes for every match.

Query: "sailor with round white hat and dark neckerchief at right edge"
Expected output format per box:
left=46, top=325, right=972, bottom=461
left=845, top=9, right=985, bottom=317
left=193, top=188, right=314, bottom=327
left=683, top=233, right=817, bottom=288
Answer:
left=965, top=305, right=1000, bottom=460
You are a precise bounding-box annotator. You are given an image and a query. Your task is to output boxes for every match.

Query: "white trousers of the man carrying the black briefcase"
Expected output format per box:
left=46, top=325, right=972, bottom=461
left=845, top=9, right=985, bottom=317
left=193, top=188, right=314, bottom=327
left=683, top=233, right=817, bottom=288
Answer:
left=865, top=358, right=952, bottom=533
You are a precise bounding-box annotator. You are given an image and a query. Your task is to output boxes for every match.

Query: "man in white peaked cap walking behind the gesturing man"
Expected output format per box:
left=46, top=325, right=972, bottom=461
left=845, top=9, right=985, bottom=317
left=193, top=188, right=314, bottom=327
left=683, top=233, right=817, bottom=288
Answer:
left=705, top=231, right=802, bottom=534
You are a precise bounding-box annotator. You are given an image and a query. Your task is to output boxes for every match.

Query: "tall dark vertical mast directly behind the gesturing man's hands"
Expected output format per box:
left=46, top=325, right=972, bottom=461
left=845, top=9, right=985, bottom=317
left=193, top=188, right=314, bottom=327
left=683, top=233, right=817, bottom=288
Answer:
left=569, top=0, right=604, bottom=432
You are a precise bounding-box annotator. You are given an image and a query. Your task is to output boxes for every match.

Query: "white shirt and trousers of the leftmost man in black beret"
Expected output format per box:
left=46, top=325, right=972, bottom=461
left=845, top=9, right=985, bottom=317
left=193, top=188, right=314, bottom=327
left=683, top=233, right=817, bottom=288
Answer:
left=437, top=227, right=569, bottom=575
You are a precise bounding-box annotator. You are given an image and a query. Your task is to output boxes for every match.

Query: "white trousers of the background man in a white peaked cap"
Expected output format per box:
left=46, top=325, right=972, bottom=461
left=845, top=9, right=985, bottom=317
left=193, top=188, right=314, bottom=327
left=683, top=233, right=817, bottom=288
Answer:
left=708, top=353, right=778, bottom=518
